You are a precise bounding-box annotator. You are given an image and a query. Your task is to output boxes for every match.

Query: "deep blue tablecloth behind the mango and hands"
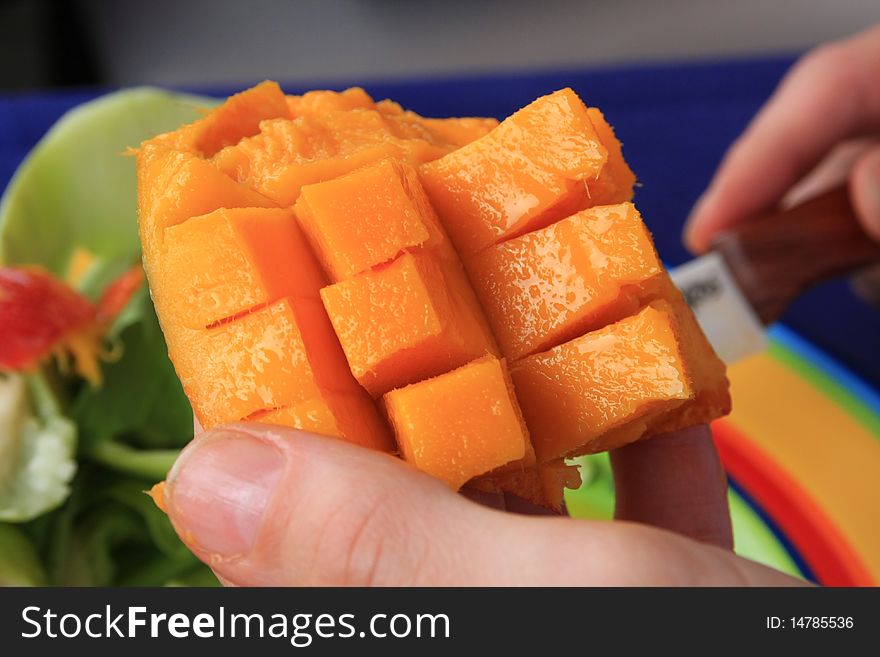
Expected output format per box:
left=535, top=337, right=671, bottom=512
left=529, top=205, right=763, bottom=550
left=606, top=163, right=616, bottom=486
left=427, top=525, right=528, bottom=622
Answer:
left=0, top=58, right=880, bottom=388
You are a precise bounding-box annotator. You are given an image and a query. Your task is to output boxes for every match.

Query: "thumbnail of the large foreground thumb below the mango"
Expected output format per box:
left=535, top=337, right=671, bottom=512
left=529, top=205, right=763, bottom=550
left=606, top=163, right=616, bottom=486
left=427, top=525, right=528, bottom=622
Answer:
left=168, top=431, right=284, bottom=558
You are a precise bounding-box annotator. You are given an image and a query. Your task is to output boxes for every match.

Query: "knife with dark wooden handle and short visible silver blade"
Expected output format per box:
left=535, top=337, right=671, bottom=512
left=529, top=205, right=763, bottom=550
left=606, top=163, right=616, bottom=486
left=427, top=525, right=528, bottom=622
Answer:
left=670, top=185, right=880, bottom=363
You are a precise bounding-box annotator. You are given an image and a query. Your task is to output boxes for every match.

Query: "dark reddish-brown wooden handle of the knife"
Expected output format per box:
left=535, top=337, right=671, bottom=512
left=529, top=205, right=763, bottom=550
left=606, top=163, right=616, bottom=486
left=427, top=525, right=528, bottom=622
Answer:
left=712, top=186, right=880, bottom=324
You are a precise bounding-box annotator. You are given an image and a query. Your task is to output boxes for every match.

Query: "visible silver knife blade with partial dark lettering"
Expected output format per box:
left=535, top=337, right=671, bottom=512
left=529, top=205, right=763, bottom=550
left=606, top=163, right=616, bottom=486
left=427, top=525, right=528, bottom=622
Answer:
left=670, top=253, right=767, bottom=363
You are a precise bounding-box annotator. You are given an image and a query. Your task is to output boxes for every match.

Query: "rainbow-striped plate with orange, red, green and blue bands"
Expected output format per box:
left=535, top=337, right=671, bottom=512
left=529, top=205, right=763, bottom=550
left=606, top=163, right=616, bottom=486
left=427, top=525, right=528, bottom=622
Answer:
left=566, top=325, right=880, bottom=586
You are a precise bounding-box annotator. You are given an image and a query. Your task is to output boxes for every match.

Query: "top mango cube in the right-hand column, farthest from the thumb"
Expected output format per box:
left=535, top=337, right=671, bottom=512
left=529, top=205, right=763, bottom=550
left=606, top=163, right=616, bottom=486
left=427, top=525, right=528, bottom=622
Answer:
left=421, top=89, right=607, bottom=258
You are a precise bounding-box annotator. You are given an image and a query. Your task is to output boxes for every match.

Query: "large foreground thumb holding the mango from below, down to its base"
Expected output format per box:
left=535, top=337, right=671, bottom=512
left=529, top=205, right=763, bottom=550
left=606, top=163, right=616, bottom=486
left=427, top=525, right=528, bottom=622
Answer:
left=165, top=423, right=795, bottom=586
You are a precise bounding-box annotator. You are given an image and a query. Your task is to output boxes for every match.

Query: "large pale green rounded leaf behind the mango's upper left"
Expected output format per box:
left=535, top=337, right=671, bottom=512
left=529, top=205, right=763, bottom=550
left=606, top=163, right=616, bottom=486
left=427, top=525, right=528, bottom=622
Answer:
left=0, top=88, right=216, bottom=293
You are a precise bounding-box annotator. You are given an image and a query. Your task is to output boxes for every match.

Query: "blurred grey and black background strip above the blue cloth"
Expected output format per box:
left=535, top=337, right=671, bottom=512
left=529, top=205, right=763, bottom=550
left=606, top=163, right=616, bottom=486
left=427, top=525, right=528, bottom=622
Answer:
left=0, top=0, right=880, bottom=89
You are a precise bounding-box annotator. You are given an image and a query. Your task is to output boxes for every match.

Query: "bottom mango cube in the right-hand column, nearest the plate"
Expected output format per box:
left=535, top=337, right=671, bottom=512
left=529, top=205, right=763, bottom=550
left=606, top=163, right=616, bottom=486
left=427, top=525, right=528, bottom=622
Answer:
left=511, top=301, right=694, bottom=463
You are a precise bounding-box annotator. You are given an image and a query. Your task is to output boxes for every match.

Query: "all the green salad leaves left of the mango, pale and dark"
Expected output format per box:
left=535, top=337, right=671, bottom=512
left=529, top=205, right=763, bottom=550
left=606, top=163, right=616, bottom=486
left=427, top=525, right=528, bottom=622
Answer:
left=0, top=88, right=216, bottom=585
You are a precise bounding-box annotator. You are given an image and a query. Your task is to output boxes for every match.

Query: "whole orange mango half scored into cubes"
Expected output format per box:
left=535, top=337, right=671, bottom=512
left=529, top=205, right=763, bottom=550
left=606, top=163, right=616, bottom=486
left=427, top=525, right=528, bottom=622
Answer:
left=137, top=83, right=730, bottom=508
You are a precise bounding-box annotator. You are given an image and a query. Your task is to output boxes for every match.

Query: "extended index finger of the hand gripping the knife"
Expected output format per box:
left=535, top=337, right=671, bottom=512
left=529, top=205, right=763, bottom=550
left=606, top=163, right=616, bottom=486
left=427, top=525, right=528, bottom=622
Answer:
left=685, top=26, right=880, bottom=252
